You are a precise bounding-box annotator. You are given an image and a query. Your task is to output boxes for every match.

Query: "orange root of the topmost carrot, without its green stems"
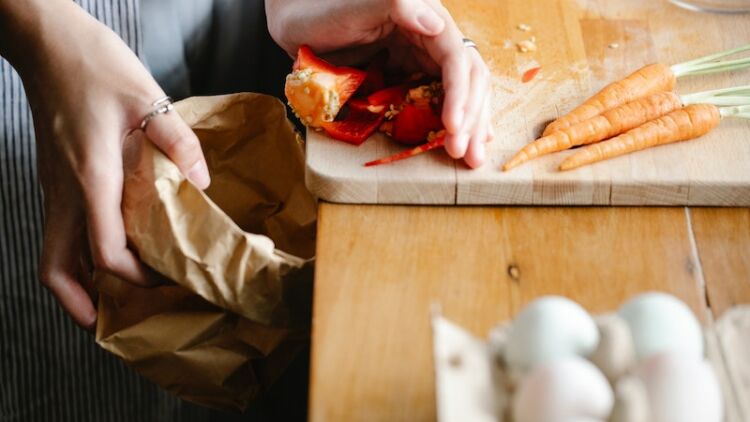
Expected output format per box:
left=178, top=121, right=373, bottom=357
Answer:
left=542, top=63, right=676, bottom=136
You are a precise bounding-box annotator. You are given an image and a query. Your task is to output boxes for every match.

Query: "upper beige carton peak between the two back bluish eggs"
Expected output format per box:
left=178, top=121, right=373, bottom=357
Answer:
left=590, top=314, right=635, bottom=382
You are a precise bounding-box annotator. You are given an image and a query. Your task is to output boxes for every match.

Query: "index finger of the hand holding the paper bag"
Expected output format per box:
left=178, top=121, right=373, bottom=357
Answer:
left=84, top=157, right=149, bottom=285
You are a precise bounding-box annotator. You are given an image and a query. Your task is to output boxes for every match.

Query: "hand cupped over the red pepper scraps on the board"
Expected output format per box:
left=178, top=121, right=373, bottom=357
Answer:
left=266, top=0, right=494, bottom=167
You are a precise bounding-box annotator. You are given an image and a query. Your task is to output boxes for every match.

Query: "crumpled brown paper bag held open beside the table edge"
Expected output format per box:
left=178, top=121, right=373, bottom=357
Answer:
left=96, top=94, right=316, bottom=409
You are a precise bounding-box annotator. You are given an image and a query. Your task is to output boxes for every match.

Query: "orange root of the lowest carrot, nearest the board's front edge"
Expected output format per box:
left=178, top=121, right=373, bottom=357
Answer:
left=560, top=104, right=721, bottom=170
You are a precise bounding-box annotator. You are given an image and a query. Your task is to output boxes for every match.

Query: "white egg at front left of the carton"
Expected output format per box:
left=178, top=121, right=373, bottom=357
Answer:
left=513, top=357, right=614, bottom=422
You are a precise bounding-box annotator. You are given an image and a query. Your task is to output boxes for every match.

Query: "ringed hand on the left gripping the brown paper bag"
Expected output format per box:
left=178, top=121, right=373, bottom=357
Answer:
left=5, top=0, right=210, bottom=329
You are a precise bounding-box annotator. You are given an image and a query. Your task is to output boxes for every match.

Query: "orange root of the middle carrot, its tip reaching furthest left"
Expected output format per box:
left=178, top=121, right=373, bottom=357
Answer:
left=503, top=92, right=682, bottom=171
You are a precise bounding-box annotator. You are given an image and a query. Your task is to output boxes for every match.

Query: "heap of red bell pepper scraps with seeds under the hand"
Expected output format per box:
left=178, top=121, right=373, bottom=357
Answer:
left=285, top=46, right=445, bottom=166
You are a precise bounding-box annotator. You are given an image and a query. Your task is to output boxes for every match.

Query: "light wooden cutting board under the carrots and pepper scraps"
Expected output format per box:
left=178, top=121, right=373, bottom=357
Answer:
left=307, top=0, right=750, bottom=206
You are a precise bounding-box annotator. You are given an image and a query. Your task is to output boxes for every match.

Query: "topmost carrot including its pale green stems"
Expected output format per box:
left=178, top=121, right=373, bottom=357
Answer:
left=542, top=44, right=750, bottom=136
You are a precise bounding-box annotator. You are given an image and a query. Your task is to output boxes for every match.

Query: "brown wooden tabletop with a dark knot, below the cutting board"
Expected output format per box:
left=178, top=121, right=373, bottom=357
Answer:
left=310, top=204, right=750, bottom=421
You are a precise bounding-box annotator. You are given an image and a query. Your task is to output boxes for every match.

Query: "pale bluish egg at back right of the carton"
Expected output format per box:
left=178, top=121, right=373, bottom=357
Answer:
left=619, top=292, right=703, bottom=359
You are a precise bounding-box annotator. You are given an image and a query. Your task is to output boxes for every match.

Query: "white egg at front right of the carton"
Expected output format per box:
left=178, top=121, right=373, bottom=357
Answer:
left=636, top=353, right=724, bottom=422
